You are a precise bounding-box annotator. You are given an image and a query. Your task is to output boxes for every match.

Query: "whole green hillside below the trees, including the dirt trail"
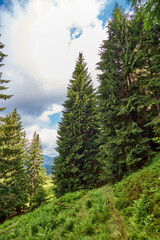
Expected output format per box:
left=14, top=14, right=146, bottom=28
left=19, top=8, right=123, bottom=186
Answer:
left=0, top=155, right=160, bottom=240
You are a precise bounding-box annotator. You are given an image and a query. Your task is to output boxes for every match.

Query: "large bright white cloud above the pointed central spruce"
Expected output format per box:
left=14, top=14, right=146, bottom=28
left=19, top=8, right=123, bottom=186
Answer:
left=2, top=0, right=105, bottom=91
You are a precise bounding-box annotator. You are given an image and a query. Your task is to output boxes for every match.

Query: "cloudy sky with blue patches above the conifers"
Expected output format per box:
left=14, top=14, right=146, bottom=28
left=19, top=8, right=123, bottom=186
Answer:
left=0, top=0, right=129, bottom=156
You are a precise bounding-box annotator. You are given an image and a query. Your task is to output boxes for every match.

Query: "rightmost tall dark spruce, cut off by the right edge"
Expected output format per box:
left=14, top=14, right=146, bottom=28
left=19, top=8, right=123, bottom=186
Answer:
left=125, top=9, right=160, bottom=150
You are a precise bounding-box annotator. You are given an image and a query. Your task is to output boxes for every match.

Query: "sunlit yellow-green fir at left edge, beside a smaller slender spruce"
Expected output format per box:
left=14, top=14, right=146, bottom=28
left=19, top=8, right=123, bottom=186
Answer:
left=0, top=109, right=26, bottom=218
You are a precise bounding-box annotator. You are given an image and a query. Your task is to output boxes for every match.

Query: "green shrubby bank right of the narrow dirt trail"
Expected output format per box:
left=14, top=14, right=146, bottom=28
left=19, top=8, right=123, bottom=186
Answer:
left=114, top=154, right=160, bottom=240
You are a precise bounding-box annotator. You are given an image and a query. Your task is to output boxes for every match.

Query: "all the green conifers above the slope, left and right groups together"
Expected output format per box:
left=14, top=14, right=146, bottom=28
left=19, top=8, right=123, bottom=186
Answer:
left=0, top=1, right=160, bottom=218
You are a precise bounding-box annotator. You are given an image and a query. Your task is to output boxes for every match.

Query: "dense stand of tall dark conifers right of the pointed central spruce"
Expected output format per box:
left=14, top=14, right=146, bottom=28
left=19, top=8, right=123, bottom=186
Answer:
left=98, top=5, right=160, bottom=181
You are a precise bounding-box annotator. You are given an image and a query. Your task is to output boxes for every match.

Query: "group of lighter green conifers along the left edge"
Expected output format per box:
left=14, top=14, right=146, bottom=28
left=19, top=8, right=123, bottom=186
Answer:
left=0, top=83, right=45, bottom=219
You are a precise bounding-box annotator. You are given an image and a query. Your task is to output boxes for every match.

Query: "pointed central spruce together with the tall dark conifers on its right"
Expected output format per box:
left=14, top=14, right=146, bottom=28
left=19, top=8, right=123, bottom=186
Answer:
left=53, top=1, right=160, bottom=196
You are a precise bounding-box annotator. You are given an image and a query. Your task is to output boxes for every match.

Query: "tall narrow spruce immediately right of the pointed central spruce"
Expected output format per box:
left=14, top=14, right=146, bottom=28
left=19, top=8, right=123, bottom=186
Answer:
left=98, top=5, right=126, bottom=180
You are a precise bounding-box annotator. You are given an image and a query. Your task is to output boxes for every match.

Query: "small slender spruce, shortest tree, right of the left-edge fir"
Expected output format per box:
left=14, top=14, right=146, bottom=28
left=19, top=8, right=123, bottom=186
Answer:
left=26, top=132, right=44, bottom=202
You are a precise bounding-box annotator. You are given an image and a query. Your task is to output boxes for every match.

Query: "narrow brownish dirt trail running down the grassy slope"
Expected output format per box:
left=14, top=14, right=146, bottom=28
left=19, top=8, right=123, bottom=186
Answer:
left=109, top=189, right=128, bottom=240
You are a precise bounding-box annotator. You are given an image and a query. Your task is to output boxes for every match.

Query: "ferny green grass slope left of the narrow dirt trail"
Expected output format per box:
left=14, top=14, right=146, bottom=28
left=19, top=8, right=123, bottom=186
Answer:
left=0, top=186, right=128, bottom=240
